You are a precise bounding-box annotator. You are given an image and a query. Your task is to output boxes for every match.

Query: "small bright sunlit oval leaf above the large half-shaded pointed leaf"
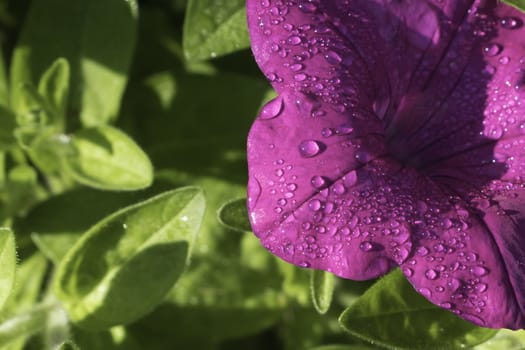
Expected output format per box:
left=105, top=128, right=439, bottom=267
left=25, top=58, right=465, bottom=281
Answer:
left=66, top=126, right=153, bottom=190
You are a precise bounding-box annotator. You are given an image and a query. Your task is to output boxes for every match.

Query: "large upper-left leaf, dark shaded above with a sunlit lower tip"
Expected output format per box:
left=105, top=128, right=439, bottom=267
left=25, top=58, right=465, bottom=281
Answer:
left=10, top=0, right=137, bottom=126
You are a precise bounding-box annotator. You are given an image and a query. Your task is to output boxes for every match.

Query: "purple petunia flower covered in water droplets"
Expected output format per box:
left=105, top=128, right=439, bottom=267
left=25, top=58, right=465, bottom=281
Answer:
left=247, top=0, right=525, bottom=329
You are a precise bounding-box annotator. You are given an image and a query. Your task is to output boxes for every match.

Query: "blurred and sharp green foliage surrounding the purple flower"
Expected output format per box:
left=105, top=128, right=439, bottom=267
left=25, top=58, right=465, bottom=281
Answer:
left=0, top=0, right=525, bottom=350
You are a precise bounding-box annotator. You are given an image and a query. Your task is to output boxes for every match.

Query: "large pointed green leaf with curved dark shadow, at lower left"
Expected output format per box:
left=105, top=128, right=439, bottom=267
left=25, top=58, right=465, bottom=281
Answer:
left=55, top=187, right=205, bottom=330
